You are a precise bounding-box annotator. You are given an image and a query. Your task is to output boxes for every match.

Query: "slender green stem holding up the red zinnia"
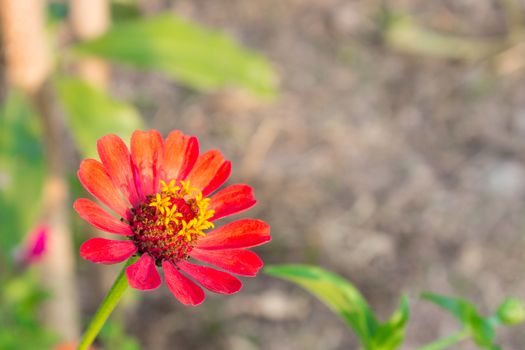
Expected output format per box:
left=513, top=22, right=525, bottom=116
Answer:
left=77, top=257, right=137, bottom=350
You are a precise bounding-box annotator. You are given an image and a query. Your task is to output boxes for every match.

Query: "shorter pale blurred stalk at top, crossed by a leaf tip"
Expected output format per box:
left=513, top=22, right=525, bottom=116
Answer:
left=70, top=0, right=111, bottom=90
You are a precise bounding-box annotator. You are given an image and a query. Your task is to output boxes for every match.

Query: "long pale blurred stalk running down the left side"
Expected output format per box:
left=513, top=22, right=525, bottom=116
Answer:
left=0, top=0, right=79, bottom=340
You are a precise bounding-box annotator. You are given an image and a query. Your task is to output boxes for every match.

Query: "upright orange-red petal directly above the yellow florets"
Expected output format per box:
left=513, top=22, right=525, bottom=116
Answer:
left=163, top=130, right=199, bottom=182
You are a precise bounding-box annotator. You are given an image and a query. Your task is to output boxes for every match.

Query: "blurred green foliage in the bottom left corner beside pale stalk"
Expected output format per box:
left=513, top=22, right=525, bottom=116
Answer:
left=0, top=273, right=57, bottom=350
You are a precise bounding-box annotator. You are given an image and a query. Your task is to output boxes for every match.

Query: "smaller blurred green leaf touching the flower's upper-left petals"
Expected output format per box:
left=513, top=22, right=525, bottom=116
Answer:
left=56, top=78, right=143, bottom=157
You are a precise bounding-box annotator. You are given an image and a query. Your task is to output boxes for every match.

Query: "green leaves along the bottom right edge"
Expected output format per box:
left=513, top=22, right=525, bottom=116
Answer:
left=265, top=265, right=525, bottom=350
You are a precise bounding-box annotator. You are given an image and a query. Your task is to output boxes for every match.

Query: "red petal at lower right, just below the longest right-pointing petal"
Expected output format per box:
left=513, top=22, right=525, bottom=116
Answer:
left=190, top=248, right=263, bottom=276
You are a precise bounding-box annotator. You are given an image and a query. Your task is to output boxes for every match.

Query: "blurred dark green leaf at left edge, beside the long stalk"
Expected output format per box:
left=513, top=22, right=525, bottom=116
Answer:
left=0, top=91, right=45, bottom=256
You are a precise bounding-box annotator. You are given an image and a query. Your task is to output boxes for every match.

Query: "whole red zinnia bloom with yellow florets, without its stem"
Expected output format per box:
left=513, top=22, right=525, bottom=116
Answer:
left=74, top=130, right=270, bottom=305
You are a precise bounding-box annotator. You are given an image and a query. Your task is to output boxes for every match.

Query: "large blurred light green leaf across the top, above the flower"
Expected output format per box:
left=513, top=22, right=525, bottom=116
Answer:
left=74, top=15, right=277, bottom=98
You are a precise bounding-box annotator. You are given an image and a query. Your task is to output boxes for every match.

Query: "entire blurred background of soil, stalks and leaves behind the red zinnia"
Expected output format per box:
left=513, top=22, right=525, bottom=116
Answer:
left=0, top=0, right=525, bottom=350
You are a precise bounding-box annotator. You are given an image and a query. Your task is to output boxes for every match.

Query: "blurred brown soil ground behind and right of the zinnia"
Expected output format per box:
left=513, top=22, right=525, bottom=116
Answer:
left=80, top=0, right=525, bottom=350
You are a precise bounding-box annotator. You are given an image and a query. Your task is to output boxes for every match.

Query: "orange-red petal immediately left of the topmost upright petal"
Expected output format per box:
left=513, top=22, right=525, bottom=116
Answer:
left=97, top=134, right=143, bottom=206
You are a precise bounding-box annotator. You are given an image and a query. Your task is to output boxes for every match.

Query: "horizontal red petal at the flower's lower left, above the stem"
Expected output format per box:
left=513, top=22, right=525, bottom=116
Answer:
left=80, top=238, right=137, bottom=264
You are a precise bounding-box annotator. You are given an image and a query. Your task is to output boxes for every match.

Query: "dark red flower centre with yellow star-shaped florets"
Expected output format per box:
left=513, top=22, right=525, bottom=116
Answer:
left=130, top=180, right=215, bottom=266
